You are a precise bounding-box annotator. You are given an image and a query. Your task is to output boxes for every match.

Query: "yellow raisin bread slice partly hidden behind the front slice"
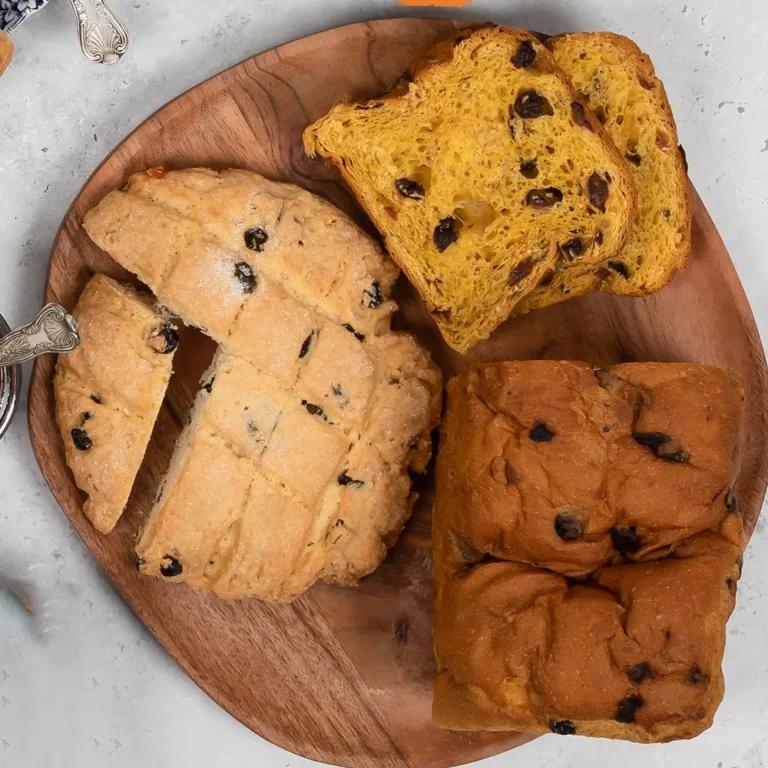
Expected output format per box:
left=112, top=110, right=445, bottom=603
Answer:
left=520, top=32, right=692, bottom=311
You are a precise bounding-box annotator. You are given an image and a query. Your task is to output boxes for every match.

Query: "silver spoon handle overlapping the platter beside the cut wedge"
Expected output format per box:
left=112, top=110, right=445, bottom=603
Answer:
left=0, top=304, right=80, bottom=365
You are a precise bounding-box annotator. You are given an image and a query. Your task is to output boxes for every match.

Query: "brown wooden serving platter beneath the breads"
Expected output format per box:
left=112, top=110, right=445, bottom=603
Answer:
left=24, top=19, right=768, bottom=768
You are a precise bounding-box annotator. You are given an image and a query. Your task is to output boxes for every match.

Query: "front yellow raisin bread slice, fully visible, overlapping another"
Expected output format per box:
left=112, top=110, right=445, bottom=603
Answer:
left=304, top=27, right=636, bottom=352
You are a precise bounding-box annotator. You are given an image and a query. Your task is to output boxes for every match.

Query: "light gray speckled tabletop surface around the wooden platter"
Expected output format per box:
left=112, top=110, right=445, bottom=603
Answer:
left=0, top=0, right=768, bottom=768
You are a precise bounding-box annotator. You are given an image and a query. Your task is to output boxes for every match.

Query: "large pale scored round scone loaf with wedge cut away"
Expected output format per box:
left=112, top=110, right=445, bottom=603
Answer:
left=85, top=169, right=442, bottom=600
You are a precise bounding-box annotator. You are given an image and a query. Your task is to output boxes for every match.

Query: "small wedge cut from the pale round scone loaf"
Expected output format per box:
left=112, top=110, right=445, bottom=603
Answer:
left=54, top=275, right=178, bottom=533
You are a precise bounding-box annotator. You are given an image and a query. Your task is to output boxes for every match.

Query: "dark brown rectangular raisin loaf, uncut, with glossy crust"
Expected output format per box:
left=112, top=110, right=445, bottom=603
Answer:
left=433, top=361, right=743, bottom=741
